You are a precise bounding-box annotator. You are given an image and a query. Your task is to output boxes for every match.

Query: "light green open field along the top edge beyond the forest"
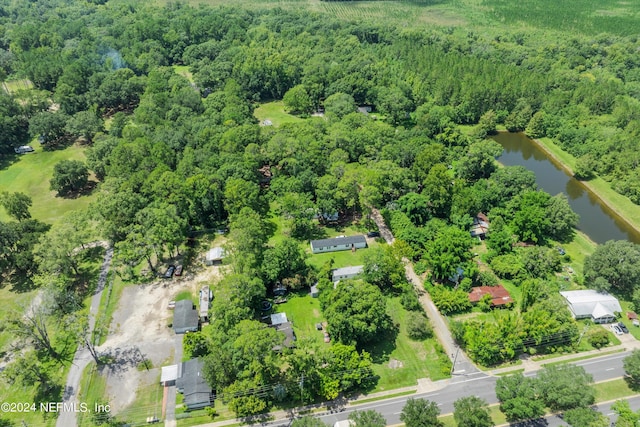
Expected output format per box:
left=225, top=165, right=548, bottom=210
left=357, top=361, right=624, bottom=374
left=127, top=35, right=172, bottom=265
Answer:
left=156, top=0, right=640, bottom=35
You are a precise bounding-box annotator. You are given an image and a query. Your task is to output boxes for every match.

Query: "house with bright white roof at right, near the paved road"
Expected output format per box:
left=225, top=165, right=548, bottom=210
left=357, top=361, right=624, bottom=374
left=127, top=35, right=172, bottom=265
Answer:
left=560, top=289, right=622, bottom=323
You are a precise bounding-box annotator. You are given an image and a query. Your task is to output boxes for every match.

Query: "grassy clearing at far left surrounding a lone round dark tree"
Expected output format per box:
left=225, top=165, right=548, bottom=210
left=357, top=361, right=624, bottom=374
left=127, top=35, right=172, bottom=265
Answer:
left=0, top=143, right=95, bottom=224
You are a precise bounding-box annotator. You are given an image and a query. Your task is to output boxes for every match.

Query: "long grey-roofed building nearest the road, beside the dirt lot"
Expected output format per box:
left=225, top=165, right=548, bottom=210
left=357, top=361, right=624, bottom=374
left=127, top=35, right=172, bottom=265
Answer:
left=176, top=359, right=214, bottom=411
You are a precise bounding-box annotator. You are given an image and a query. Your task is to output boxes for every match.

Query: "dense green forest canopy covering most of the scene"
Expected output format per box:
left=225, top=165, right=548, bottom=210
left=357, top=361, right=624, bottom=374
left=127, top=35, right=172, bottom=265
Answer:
left=0, top=0, right=640, bottom=422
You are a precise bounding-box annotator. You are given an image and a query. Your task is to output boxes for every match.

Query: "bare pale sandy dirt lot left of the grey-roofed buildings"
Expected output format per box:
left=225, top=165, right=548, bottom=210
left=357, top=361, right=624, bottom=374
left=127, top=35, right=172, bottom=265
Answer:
left=98, top=265, right=223, bottom=414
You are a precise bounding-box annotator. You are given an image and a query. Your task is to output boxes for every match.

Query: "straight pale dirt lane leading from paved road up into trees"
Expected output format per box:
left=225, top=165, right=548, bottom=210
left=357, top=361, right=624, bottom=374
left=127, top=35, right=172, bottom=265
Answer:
left=371, top=208, right=480, bottom=375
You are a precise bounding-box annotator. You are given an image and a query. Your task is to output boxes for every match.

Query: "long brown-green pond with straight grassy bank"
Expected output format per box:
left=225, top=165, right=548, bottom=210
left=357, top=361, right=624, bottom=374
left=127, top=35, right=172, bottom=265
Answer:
left=493, top=132, right=640, bottom=243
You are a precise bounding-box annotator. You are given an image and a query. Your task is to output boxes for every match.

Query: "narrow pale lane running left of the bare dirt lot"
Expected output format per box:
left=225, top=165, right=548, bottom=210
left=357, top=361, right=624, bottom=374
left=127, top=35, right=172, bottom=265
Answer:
left=56, top=242, right=113, bottom=427
